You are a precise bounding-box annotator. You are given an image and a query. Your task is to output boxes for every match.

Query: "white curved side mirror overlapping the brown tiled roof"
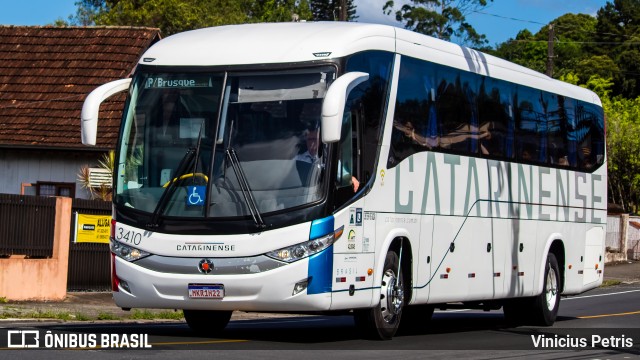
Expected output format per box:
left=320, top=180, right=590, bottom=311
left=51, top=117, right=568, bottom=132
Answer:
left=80, top=78, right=131, bottom=146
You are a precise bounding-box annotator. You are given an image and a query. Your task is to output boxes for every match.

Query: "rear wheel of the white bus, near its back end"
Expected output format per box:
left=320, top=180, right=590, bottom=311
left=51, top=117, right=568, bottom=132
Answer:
left=532, top=253, right=560, bottom=326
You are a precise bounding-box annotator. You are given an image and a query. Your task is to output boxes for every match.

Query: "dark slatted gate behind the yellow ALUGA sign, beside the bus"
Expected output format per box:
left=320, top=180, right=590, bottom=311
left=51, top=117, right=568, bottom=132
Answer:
left=67, top=199, right=111, bottom=291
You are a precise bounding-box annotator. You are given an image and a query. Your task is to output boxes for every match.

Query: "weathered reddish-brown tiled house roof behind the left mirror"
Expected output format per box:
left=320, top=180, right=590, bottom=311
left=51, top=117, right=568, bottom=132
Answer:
left=0, top=26, right=160, bottom=148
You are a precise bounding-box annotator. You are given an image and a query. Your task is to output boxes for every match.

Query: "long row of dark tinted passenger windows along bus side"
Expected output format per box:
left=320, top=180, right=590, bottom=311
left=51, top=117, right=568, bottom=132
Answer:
left=387, top=57, right=605, bottom=171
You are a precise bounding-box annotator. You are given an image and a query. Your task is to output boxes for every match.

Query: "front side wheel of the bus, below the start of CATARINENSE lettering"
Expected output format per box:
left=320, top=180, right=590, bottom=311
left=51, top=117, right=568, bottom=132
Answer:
left=354, top=251, right=404, bottom=340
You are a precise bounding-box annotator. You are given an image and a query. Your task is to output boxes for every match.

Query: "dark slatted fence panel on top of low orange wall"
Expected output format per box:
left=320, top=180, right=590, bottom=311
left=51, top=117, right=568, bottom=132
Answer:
left=0, top=194, right=56, bottom=258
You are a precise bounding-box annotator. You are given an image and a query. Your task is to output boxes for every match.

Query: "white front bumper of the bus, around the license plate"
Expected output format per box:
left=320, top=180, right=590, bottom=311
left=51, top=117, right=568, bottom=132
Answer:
left=113, top=257, right=331, bottom=311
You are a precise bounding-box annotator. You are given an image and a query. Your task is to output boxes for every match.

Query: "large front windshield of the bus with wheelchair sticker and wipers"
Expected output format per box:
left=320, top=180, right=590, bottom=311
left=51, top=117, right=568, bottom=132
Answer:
left=115, top=66, right=335, bottom=217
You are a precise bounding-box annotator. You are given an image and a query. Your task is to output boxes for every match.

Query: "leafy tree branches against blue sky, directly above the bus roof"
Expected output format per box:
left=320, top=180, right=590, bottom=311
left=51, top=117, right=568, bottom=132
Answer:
left=383, top=0, right=493, bottom=47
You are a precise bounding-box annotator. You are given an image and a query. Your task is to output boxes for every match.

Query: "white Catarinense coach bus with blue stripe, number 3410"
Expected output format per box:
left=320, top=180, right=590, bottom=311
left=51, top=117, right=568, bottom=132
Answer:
left=82, top=22, right=607, bottom=339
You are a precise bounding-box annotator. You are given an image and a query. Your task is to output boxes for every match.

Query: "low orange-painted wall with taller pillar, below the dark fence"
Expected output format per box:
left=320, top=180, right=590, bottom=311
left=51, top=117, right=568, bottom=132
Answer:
left=0, top=197, right=71, bottom=301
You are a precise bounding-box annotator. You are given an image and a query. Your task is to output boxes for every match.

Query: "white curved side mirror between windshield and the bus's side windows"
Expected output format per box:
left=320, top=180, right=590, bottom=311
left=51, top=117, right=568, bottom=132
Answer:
left=321, top=71, right=369, bottom=143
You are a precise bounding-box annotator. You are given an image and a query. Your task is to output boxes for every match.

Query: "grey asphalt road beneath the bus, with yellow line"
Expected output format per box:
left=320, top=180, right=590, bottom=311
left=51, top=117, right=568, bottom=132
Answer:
left=0, top=283, right=640, bottom=360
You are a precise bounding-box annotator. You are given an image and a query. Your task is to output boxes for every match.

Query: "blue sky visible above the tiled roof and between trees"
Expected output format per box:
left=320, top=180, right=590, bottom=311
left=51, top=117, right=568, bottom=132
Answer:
left=0, top=0, right=607, bottom=46
